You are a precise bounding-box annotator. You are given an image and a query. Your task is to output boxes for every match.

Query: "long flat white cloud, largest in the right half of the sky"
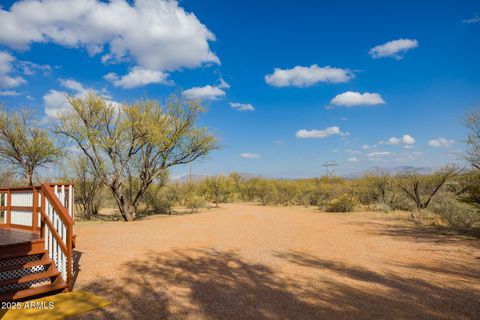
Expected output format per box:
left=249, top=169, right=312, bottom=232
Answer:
left=265, top=64, right=355, bottom=87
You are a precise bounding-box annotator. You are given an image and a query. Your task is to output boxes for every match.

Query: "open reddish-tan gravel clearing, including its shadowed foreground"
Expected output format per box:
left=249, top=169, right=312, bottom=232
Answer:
left=71, top=204, right=480, bottom=319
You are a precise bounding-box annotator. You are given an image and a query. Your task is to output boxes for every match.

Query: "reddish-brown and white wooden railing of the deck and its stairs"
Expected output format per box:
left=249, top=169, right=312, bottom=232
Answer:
left=0, top=183, right=74, bottom=289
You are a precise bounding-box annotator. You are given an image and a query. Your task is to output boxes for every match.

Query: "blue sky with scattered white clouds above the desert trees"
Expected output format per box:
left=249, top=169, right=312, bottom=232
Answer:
left=0, top=0, right=480, bottom=177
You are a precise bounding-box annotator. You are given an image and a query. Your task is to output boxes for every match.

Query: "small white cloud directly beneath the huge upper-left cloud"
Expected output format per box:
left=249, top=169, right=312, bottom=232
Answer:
left=103, top=67, right=171, bottom=89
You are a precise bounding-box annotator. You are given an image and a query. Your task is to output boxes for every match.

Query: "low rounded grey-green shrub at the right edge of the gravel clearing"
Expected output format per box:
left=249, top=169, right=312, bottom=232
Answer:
left=432, top=196, right=480, bottom=228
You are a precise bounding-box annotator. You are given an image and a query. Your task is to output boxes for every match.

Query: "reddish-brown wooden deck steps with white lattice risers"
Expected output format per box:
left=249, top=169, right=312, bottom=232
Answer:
left=0, top=239, right=68, bottom=302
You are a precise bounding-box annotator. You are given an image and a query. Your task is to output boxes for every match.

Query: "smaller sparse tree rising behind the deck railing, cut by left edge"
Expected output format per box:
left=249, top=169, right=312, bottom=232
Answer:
left=0, top=108, right=62, bottom=185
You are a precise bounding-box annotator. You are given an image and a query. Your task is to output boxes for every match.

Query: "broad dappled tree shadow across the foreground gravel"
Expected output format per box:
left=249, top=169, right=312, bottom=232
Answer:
left=72, top=249, right=480, bottom=320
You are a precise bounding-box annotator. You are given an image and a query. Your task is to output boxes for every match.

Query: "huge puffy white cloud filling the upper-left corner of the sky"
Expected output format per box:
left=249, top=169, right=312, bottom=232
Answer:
left=0, top=0, right=220, bottom=71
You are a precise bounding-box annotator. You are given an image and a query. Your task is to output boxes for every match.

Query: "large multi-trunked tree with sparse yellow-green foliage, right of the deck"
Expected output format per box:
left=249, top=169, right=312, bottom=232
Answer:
left=56, top=92, right=217, bottom=221
